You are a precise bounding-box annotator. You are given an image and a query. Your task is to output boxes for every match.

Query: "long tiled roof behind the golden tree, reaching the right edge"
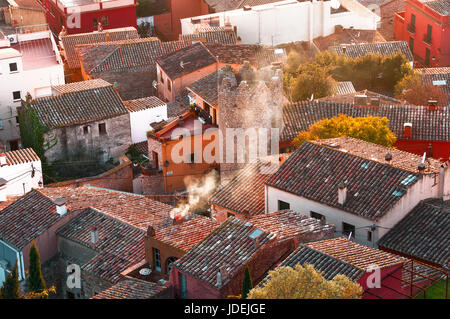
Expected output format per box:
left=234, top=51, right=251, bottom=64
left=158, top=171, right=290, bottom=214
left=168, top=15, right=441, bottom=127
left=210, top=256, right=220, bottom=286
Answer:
left=281, top=100, right=450, bottom=141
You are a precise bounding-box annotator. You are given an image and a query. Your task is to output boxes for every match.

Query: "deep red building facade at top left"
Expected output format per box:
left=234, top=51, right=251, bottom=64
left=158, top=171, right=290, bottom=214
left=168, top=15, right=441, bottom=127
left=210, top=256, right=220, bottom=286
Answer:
left=37, top=0, right=137, bottom=34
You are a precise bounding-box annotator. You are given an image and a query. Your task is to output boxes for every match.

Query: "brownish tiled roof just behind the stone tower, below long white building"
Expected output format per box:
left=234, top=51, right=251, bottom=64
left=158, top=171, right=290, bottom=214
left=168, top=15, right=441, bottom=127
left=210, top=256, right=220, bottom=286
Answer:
left=205, top=43, right=286, bottom=69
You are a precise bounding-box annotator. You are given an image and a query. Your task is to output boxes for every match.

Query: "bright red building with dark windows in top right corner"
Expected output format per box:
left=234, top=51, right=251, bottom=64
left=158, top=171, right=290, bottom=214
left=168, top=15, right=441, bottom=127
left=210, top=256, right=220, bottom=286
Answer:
left=394, top=0, right=450, bottom=67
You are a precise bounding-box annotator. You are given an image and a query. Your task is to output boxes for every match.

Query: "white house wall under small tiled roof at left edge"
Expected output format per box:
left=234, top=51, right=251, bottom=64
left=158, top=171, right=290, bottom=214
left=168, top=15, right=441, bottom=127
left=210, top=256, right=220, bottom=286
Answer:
left=0, top=161, right=43, bottom=196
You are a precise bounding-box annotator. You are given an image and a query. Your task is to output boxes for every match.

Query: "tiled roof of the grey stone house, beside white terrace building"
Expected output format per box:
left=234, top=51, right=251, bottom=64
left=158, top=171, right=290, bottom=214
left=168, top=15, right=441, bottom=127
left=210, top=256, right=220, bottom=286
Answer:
left=30, top=80, right=128, bottom=128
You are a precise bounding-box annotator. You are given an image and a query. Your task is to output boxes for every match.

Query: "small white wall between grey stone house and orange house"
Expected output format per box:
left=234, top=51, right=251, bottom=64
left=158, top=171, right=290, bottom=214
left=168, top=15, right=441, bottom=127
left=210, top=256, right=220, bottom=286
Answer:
left=130, top=104, right=167, bottom=144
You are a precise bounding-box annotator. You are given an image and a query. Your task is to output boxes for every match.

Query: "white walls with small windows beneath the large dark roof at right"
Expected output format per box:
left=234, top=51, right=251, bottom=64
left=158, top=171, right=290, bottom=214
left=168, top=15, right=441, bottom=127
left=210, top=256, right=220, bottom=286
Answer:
left=266, top=169, right=450, bottom=246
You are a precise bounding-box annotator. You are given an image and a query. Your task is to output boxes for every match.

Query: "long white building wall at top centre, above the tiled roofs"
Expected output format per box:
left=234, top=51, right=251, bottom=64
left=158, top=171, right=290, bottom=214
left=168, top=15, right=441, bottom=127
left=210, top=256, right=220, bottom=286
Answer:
left=181, top=0, right=380, bottom=45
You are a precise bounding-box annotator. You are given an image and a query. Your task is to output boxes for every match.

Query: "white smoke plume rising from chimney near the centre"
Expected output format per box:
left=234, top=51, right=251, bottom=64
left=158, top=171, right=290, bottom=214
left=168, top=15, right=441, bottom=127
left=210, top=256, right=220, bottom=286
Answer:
left=170, top=170, right=219, bottom=218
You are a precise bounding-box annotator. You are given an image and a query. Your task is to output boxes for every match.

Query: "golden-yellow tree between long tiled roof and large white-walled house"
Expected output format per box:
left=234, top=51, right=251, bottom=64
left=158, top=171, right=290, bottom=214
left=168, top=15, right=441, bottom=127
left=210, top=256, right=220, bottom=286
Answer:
left=292, top=114, right=397, bottom=147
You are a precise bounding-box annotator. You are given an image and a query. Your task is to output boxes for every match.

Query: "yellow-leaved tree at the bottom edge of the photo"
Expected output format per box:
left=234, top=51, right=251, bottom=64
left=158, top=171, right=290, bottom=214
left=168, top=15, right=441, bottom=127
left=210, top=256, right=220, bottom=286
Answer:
left=247, top=264, right=363, bottom=299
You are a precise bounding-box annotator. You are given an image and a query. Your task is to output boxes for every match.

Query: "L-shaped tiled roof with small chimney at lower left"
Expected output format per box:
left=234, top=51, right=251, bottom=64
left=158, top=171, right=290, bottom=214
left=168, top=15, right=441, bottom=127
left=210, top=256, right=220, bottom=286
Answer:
left=57, top=208, right=145, bottom=283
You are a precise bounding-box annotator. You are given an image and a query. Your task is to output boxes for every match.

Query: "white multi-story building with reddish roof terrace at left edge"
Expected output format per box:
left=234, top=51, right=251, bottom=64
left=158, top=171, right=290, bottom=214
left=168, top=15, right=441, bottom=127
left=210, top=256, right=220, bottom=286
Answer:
left=0, top=25, right=64, bottom=151
